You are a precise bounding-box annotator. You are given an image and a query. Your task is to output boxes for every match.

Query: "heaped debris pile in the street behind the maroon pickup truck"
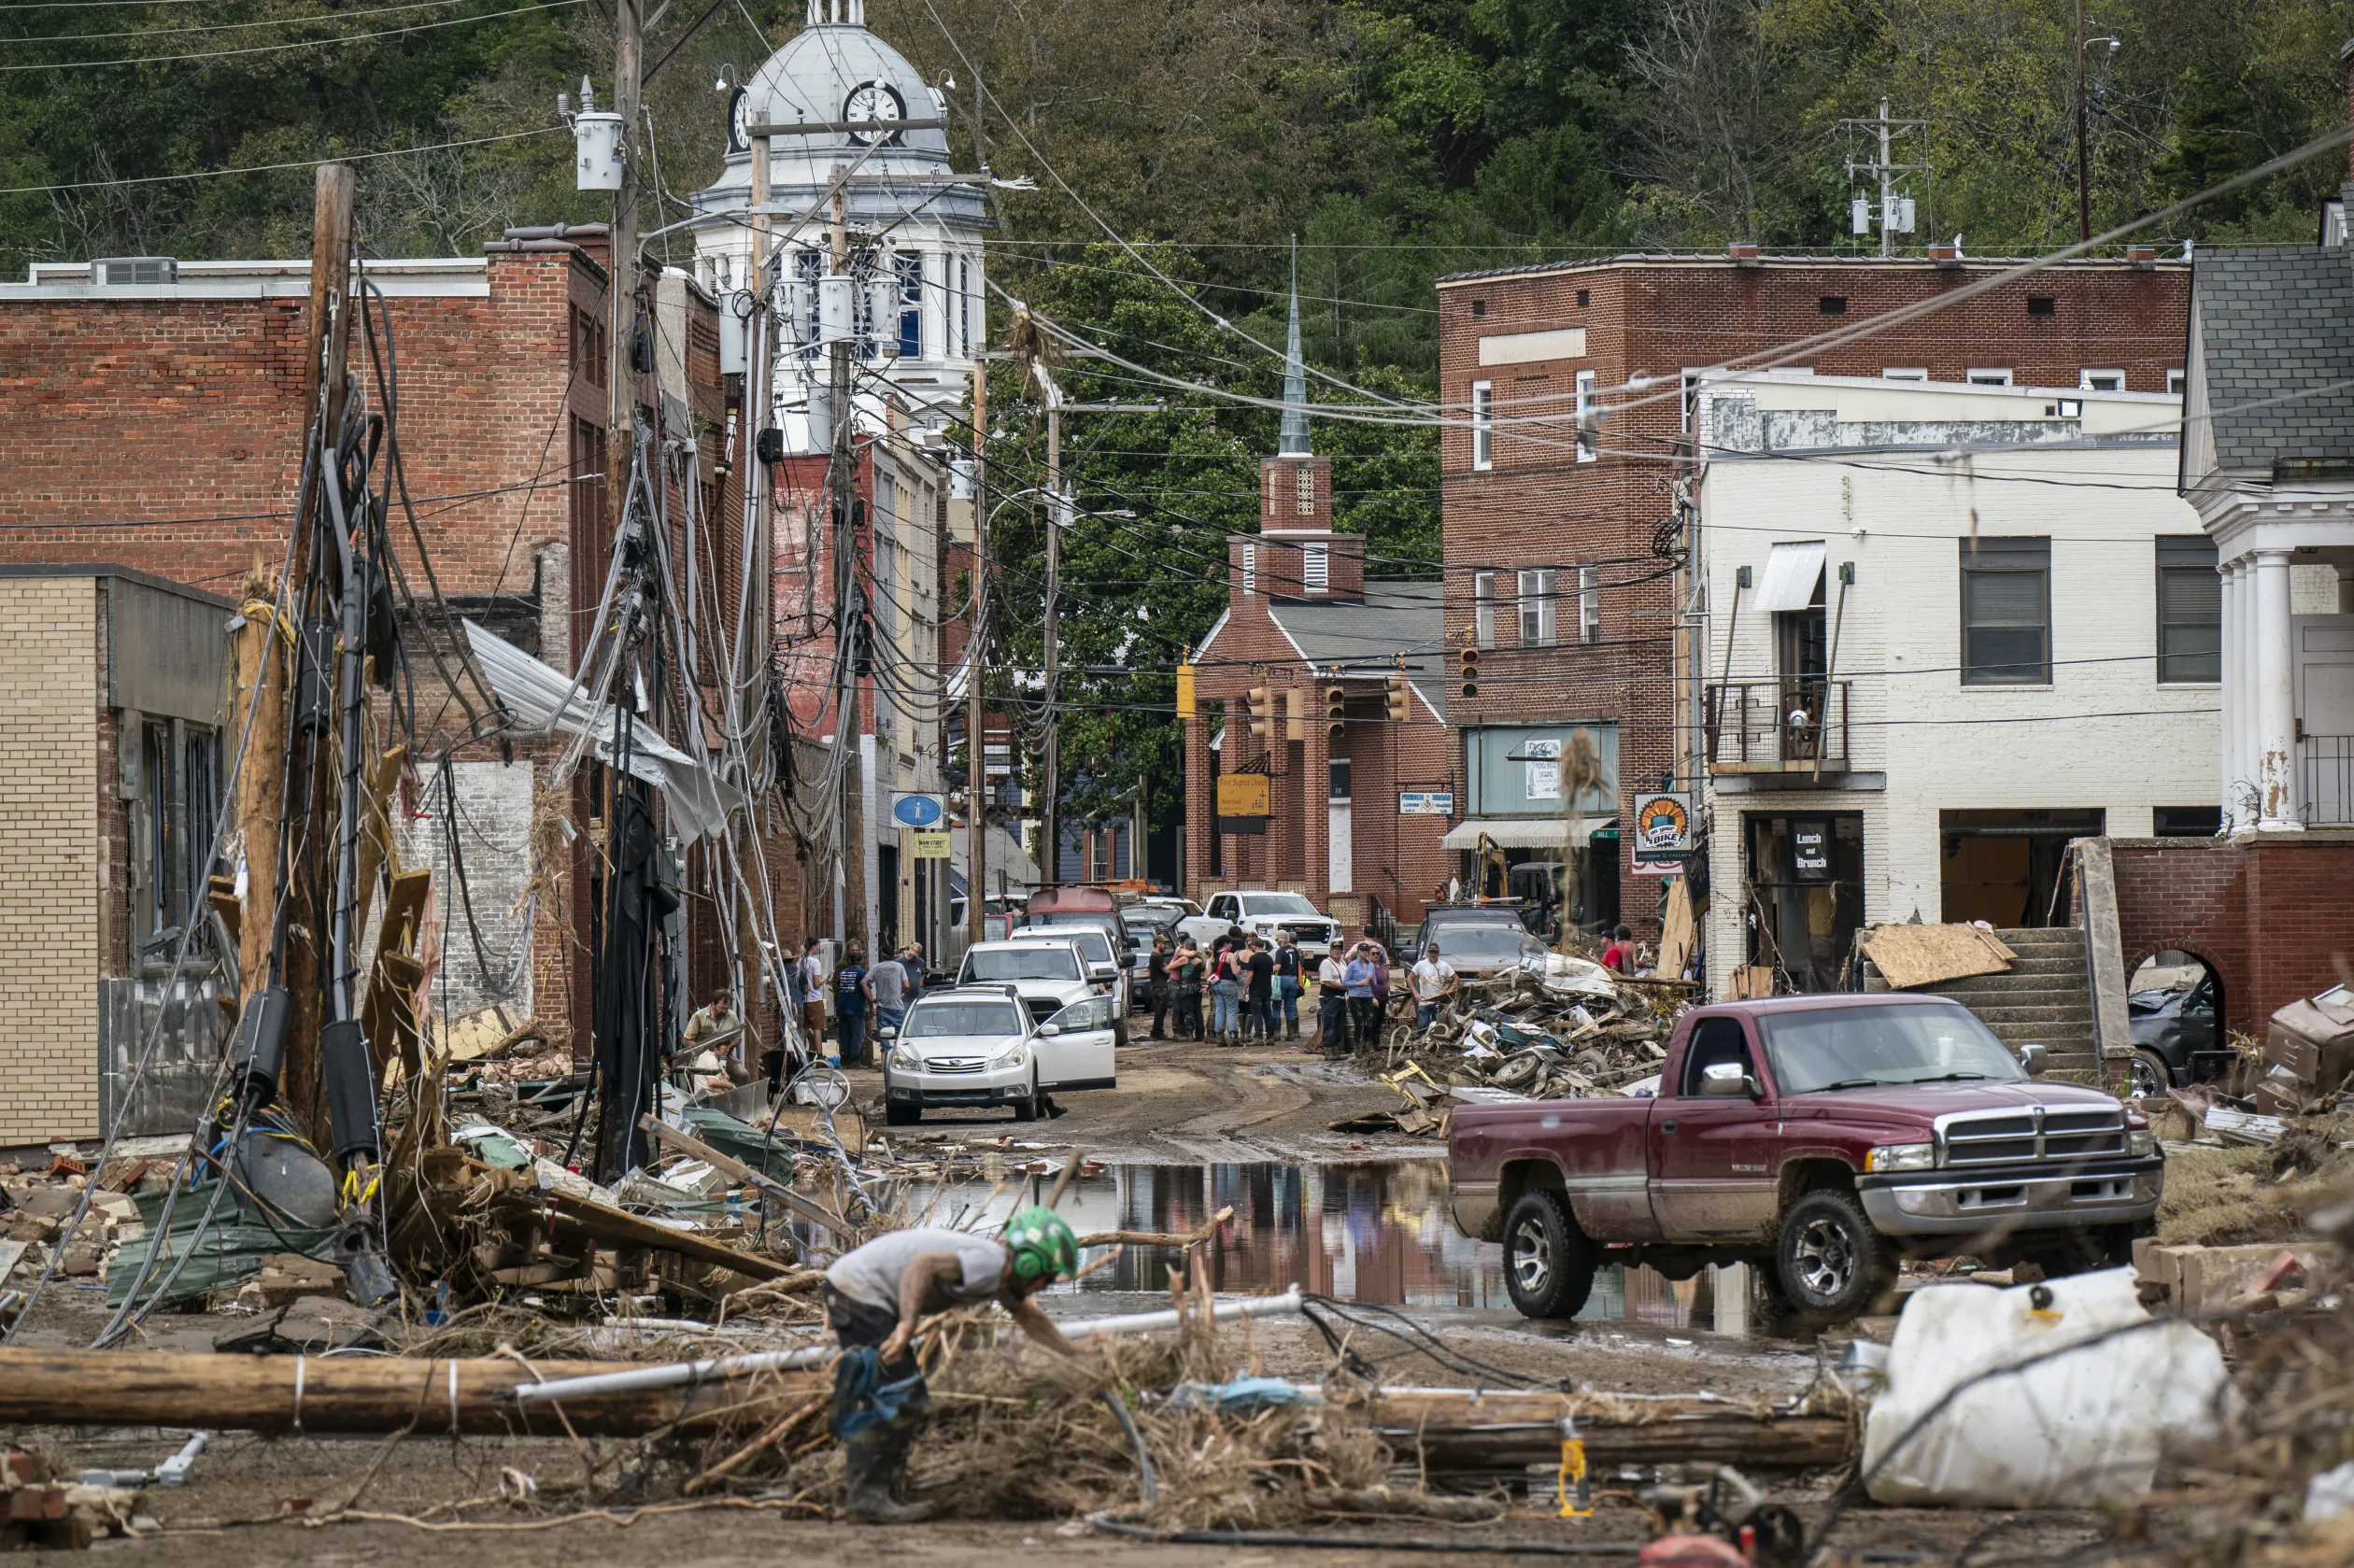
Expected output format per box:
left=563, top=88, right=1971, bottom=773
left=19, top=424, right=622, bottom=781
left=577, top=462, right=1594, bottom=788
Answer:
left=1332, top=954, right=1697, bottom=1137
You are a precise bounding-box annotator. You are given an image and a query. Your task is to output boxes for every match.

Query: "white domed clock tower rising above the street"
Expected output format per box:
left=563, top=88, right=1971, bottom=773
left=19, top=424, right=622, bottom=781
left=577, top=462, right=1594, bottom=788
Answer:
left=694, top=0, right=993, bottom=452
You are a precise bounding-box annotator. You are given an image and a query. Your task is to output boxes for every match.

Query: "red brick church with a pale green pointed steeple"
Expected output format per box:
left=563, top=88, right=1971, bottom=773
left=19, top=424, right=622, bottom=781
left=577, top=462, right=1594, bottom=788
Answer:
left=1177, top=302, right=1459, bottom=930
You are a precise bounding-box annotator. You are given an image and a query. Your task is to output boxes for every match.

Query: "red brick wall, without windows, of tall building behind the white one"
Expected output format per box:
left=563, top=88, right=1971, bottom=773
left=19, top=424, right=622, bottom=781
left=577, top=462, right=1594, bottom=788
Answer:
left=1439, top=257, right=2190, bottom=930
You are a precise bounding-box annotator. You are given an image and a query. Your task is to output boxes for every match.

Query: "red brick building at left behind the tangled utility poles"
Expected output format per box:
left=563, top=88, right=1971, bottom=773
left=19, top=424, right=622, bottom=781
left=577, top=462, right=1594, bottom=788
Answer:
left=0, top=241, right=801, bottom=1073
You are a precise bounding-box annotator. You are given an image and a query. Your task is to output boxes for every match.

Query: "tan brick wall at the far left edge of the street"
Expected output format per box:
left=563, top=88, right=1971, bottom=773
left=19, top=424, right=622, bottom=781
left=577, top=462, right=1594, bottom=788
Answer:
left=0, top=577, right=101, bottom=1144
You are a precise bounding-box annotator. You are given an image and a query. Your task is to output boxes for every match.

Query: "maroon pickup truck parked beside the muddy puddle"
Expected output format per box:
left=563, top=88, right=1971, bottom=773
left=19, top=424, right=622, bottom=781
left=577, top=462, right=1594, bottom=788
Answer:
left=1448, top=996, right=2165, bottom=1319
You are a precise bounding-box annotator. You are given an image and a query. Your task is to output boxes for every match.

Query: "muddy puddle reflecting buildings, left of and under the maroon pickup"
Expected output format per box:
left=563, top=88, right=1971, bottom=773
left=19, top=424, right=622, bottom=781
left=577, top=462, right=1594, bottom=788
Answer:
left=911, top=1161, right=1747, bottom=1333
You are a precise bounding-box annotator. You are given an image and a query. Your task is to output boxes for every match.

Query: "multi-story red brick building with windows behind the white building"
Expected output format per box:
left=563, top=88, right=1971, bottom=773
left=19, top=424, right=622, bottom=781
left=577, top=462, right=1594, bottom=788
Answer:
left=1439, top=252, right=2187, bottom=930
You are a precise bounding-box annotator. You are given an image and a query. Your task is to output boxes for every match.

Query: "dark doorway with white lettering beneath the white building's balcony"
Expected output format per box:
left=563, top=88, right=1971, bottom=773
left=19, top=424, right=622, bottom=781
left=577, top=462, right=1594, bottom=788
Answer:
left=1742, top=812, right=1865, bottom=991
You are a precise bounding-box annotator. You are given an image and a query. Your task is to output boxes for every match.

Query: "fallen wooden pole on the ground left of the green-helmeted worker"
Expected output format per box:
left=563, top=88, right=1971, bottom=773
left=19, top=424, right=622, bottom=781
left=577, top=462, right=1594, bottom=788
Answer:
left=0, top=1349, right=831, bottom=1436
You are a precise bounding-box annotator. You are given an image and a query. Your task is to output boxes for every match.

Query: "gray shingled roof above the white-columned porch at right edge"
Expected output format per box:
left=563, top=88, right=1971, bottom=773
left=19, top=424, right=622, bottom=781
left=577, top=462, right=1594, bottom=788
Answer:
left=2191, top=245, right=2354, bottom=469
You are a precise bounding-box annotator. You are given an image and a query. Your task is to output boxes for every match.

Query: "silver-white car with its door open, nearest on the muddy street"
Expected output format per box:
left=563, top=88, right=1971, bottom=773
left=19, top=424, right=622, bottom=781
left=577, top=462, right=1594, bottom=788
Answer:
left=880, top=982, right=1118, bottom=1128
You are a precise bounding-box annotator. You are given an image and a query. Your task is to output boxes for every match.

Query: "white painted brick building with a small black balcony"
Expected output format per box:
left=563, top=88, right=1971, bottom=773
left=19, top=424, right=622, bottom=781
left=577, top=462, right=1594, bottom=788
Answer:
left=1685, top=372, right=2219, bottom=996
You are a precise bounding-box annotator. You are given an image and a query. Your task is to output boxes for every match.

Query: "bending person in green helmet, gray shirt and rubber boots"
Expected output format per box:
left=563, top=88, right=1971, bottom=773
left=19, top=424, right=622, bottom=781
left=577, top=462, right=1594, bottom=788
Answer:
left=824, top=1208, right=1078, bottom=1523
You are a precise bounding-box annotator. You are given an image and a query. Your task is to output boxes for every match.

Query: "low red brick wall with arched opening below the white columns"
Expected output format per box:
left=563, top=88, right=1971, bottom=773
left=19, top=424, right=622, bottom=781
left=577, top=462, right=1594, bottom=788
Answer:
left=2111, top=828, right=2354, bottom=1038
